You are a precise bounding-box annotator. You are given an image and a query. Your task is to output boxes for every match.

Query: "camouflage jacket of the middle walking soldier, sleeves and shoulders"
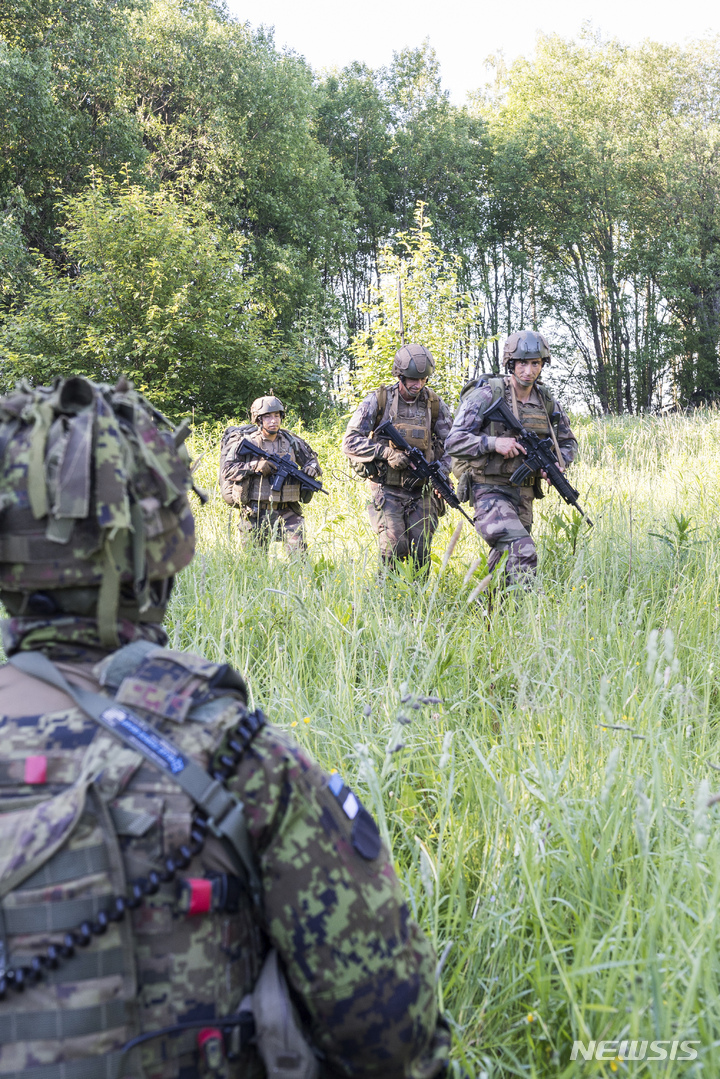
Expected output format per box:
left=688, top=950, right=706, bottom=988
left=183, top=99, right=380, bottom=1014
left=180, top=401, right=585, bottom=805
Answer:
left=342, top=382, right=452, bottom=479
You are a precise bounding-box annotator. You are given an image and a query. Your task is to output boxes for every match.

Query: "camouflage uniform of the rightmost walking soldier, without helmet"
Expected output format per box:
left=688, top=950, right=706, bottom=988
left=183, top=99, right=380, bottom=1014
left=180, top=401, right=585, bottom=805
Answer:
left=445, top=377, right=578, bottom=584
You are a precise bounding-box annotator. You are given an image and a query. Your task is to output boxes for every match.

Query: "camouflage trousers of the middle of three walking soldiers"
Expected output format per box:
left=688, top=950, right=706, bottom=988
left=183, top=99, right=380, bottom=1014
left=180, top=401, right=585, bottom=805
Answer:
left=367, top=483, right=438, bottom=571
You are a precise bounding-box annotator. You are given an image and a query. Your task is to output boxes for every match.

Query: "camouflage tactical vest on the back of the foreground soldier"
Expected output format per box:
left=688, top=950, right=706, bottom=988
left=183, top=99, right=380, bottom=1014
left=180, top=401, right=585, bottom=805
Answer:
left=0, top=642, right=266, bottom=1079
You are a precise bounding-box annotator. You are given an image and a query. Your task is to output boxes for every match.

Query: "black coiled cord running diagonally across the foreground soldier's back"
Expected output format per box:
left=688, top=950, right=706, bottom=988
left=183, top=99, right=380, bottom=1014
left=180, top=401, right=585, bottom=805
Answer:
left=0, top=708, right=267, bottom=996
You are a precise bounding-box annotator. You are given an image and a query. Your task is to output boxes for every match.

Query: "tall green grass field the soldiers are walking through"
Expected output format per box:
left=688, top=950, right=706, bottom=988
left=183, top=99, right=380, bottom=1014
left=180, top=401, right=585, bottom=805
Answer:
left=169, top=412, right=720, bottom=1079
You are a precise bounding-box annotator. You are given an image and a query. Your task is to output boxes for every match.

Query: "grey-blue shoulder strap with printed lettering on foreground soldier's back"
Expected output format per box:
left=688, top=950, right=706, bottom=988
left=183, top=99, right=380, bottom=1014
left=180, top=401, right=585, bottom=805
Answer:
left=9, top=652, right=264, bottom=904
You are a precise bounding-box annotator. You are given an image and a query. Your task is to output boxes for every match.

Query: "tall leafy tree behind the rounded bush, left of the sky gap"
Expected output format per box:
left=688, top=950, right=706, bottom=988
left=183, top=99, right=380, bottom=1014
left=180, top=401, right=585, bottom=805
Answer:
left=125, top=0, right=356, bottom=340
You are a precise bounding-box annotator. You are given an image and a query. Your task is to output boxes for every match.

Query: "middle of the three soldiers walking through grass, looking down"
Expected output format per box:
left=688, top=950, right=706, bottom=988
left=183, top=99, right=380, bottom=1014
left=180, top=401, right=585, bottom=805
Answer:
left=342, top=344, right=452, bottom=573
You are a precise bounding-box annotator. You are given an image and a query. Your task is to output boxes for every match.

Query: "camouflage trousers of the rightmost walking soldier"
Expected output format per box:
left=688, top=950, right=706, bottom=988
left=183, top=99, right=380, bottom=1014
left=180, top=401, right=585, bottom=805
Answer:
left=473, top=483, right=538, bottom=585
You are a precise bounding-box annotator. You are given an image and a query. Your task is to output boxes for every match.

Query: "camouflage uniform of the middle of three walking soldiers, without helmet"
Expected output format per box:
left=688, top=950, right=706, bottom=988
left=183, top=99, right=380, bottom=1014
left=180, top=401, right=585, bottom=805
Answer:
left=342, top=382, right=452, bottom=568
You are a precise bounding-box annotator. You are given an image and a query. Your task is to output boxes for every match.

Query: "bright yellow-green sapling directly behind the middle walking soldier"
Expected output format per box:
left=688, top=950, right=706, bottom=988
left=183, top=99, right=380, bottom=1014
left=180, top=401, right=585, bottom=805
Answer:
left=350, top=203, right=477, bottom=401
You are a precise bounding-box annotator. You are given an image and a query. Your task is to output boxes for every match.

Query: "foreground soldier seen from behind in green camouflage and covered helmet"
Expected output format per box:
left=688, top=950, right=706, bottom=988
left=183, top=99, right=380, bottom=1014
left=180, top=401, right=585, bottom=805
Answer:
left=0, top=378, right=448, bottom=1079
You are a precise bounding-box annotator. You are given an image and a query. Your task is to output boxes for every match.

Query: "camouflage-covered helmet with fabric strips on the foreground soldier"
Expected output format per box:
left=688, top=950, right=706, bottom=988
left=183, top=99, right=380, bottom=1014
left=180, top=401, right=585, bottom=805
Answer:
left=0, top=377, right=200, bottom=647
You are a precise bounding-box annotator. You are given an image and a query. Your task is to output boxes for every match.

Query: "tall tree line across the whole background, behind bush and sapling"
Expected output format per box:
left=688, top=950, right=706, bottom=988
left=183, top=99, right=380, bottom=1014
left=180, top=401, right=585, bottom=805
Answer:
left=0, top=0, right=720, bottom=413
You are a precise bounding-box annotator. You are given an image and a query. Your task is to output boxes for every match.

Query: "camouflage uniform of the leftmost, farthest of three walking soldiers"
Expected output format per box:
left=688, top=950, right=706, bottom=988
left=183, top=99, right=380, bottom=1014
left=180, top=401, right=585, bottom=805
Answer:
left=222, top=427, right=322, bottom=554
